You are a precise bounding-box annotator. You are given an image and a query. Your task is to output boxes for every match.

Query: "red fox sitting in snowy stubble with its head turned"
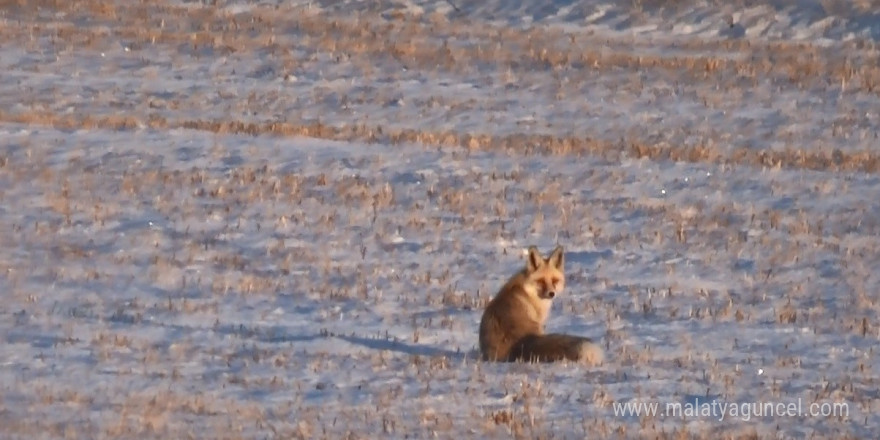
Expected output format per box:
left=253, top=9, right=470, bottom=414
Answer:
left=480, top=246, right=604, bottom=365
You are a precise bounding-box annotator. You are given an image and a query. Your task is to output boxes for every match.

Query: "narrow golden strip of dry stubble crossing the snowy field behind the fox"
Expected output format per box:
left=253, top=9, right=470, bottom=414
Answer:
left=0, top=112, right=880, bottom=173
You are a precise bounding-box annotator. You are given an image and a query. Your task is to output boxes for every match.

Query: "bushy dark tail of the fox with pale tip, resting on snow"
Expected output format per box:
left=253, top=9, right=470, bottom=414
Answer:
left=509, top=333, right=605, bottom=365
